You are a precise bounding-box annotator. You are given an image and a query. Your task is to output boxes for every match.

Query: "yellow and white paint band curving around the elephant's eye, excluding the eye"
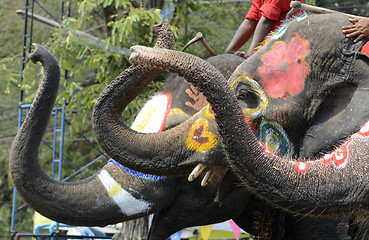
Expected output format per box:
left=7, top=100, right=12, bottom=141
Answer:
left=231, top=74, right=269, bottom=119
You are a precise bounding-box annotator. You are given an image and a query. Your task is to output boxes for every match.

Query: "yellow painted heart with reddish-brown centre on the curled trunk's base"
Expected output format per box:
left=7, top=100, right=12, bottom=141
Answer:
left=186, top=119, right=218, bottom=152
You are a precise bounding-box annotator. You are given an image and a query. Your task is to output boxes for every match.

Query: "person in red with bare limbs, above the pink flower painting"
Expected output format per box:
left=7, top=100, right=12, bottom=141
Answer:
left=225, top=0, right=304, bottom=58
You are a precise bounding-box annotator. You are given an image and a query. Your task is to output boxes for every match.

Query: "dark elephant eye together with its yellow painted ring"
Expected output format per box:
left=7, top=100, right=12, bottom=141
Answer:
left=231, top=74, right=269, bottom=119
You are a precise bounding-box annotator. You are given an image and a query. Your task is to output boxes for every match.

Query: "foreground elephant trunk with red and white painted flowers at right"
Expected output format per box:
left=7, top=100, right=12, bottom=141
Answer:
left=130, top=46, right=369, bottom=218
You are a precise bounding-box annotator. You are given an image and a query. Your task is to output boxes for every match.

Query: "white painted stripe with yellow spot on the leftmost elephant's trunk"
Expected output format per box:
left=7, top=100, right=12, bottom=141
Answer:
left=98, top=170, right=151, bottom=216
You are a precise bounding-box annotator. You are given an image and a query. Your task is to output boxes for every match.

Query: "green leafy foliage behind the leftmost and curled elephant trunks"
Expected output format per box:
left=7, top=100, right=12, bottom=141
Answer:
left=46, top=0, right=168, bottom=131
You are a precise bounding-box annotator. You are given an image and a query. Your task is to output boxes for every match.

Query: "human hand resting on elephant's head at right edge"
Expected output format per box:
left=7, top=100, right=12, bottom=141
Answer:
left=342, top=18, right=369, bottom=42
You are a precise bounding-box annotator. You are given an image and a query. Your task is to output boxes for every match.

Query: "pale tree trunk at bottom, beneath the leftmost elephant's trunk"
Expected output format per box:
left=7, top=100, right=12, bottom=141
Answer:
left=113, top=216, right=149, bottom=240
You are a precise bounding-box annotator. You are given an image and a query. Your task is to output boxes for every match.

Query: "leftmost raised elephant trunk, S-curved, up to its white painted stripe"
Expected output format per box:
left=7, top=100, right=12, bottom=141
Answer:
left=9, top=45, right=166, bottom=226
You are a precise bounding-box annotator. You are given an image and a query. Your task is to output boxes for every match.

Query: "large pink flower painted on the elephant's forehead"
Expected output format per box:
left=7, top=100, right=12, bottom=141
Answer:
left=258, top=33, right=310, bottom=99
